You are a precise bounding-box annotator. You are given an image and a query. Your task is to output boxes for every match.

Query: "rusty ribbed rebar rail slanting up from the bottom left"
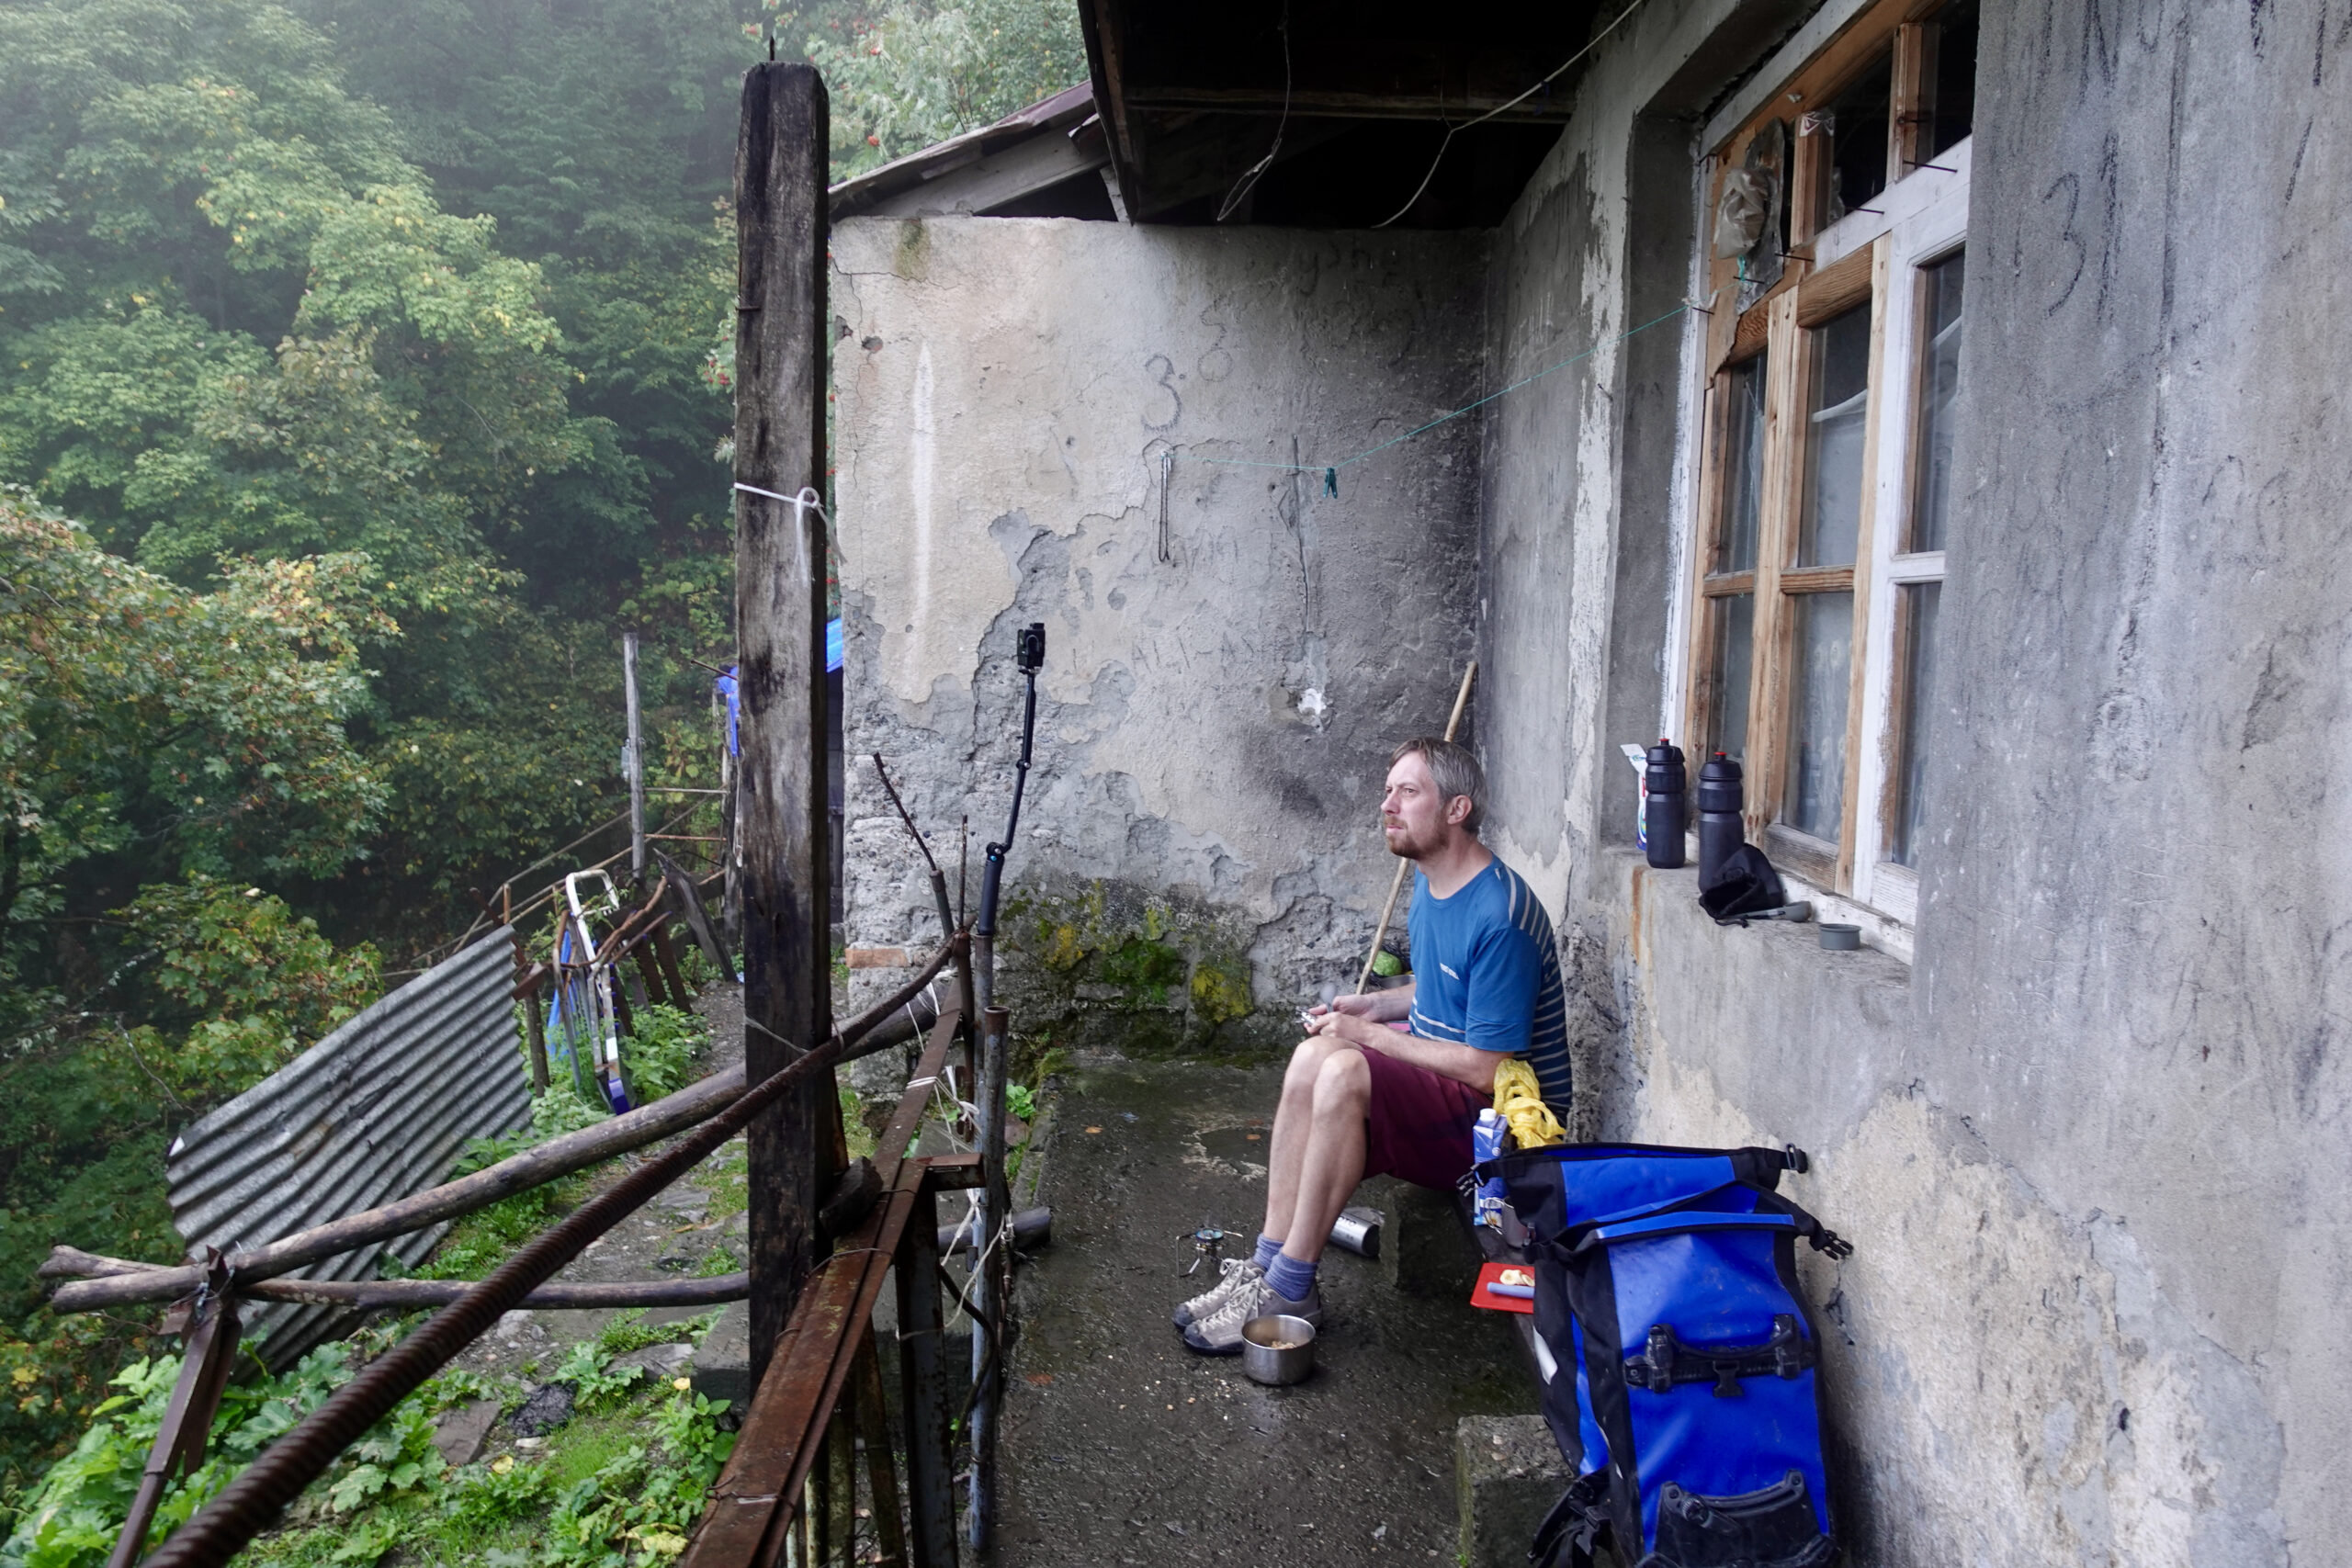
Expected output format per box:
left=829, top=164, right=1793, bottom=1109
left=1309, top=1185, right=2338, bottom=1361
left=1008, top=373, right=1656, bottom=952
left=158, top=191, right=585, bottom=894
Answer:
left=135, top=931, right=969, bottom=1568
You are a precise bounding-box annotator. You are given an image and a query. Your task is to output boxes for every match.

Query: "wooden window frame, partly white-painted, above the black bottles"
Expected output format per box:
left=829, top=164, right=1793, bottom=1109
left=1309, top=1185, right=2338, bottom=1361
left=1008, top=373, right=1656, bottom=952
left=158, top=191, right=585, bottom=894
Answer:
left=1681, top=0, right=1971, bottom=926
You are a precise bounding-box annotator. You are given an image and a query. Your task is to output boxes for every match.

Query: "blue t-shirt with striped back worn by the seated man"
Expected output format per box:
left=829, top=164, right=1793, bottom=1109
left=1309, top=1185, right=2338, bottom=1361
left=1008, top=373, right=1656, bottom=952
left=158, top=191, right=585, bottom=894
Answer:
left=1404, top=861, right=1571, bottom=1117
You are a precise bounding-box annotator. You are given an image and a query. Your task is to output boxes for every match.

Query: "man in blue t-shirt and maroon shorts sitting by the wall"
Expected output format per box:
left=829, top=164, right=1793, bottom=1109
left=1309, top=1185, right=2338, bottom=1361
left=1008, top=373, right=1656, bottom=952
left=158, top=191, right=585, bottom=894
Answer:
left=1176, top=739, right=1569, bottom=1357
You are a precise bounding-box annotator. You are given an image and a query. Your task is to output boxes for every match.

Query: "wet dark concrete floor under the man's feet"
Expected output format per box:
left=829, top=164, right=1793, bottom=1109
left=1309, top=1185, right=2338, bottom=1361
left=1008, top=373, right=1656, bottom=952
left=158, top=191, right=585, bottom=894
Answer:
left=995, top=1058, right=1536, bottom=1568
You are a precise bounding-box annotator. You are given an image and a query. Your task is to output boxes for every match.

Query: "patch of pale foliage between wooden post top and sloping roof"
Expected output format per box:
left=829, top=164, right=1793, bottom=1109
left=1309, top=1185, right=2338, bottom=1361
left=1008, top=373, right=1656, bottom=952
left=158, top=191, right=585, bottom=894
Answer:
left=809, top=0, right=1087, bottom=179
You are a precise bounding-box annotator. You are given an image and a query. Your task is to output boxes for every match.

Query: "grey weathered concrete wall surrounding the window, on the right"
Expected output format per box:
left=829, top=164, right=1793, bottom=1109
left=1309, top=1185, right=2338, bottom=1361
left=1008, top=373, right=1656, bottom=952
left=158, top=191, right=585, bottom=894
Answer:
left=1479, top=0, right=2352, bottom=1568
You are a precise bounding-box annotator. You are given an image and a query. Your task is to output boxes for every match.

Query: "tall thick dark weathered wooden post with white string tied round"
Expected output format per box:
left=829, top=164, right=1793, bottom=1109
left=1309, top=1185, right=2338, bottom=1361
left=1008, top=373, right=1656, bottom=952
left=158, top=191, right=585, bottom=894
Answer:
left=734, top=63, right=835, bottom=1384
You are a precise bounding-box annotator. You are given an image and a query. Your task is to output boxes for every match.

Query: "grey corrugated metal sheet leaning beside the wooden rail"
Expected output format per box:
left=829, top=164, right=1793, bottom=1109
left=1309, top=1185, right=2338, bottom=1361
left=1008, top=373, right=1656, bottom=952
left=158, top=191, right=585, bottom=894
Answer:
left=164, top=929, right=532, bottom=1368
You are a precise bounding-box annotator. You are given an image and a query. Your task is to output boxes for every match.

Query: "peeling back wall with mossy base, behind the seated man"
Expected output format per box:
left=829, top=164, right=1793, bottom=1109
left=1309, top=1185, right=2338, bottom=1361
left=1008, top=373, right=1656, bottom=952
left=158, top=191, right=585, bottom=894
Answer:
left=832, top=219, right=1487, bottom=1046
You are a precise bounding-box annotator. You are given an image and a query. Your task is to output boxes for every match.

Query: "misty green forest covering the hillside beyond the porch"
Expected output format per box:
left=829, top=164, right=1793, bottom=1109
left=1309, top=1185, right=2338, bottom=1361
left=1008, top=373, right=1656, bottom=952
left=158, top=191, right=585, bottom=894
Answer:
left=0, top=0, right=1087, bottom=1565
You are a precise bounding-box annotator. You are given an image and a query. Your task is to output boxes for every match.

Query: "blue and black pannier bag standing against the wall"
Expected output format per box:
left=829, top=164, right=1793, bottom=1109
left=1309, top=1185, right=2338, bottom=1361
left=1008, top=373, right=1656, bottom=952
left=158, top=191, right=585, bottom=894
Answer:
left=1479, top=1143, right=1853, bottom=1568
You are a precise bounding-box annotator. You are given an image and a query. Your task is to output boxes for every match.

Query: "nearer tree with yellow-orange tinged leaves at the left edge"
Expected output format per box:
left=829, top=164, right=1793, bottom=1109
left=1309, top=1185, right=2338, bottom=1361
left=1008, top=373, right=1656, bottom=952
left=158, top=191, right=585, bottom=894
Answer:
left=0, top=495, right=390, bottom=1001
